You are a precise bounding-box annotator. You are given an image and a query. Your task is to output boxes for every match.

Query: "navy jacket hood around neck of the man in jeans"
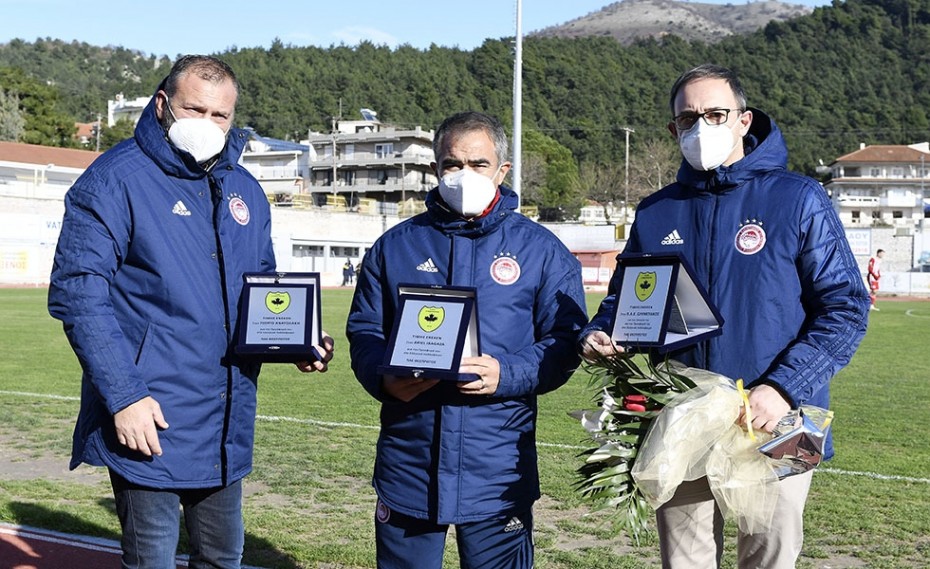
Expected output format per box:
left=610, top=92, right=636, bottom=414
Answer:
left=133, top=81, right=248, bottom=179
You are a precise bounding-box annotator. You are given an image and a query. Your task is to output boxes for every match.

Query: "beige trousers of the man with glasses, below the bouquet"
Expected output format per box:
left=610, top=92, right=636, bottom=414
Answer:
left=656, top=471, right=814, bottom=569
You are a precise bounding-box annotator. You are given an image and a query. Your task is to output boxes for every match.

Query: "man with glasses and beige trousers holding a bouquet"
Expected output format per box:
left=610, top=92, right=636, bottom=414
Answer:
left=580, top=65, right=869, bottom=569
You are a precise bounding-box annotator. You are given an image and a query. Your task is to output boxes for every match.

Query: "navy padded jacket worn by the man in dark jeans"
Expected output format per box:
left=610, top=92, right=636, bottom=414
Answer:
left=49, top=91, right=275, bottom=488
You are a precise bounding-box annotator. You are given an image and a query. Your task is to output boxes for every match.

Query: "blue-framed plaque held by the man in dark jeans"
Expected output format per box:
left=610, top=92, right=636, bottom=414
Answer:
left=235, top=273, right=323, bottom=362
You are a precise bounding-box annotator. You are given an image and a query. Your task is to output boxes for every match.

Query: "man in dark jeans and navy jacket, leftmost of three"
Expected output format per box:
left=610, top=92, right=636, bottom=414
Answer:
left=49, top=56, right=332, bottom=569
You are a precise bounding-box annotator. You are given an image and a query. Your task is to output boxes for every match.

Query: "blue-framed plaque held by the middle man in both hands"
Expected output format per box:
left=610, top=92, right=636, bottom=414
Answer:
left=378, top=284, right=481, bottom=381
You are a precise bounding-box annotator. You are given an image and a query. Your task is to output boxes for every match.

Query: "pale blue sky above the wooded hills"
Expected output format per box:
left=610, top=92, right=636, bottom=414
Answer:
left=0, top=0, right=830, bottom=58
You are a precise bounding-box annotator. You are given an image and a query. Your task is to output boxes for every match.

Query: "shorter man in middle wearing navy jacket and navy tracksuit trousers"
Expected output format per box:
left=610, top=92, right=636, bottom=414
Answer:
left=346, top=112, right=587, bottom=569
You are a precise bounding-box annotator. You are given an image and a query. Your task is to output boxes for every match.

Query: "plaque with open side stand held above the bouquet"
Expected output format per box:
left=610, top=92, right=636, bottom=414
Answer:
left=611, top=255, right=723, bottom=353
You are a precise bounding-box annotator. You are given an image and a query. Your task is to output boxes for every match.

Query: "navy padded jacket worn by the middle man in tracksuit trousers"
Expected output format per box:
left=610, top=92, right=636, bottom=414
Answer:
left=346, top=188, right=587, bottom=523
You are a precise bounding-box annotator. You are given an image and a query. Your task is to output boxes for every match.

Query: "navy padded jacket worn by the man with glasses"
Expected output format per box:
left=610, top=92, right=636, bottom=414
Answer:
left=582, top=109, right=869, bottom=457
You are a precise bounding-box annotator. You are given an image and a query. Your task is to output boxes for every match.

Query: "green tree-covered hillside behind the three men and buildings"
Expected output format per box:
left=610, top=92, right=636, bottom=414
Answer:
left=0, top=0, right=930, bottom=213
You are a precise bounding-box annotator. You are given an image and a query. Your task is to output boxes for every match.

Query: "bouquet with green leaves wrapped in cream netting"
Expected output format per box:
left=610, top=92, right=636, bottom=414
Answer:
left=577, top=354, right=833, bottom=543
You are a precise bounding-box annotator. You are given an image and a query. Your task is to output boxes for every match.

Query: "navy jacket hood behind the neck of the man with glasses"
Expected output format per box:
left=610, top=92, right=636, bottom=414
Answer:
left=678, top=107, right=788, bottom=191
